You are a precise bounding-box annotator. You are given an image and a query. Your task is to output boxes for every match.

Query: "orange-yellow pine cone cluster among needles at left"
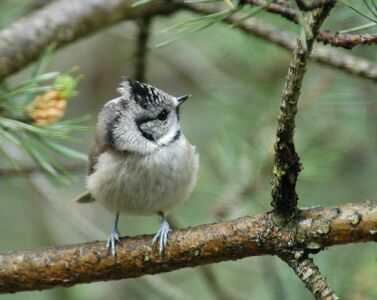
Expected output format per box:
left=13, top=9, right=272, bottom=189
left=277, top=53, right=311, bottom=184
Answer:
left=28, top=90, right=67, bottom=125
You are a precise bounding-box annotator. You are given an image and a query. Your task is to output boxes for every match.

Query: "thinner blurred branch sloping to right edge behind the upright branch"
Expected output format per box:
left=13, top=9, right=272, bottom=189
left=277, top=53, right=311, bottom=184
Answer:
left=185, top=4, right=377, bottom=81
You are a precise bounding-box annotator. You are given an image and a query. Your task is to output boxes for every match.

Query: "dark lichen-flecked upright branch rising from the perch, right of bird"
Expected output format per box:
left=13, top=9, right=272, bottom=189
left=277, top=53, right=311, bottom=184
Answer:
left=271, top=3, right=334, bottom=215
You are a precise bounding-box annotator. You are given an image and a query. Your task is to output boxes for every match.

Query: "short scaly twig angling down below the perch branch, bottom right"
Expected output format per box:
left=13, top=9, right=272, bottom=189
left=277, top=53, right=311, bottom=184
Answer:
left=279, top=252, right=339, bottom=300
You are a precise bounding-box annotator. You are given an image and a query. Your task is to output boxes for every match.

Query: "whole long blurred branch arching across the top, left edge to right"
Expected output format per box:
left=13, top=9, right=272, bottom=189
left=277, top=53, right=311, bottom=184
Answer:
left=0, top=0, right=377, bottom=80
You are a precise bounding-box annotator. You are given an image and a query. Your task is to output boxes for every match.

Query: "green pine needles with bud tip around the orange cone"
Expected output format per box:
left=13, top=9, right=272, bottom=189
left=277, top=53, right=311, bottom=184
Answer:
left=0, top=45, right=91, bottom=184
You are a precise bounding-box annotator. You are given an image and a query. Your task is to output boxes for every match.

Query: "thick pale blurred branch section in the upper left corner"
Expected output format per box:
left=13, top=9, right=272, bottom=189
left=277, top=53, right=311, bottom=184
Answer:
left=0, top=0, right=179, bottom=79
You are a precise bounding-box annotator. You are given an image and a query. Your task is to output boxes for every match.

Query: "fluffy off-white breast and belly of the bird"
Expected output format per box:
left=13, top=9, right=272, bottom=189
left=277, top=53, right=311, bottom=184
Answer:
left=87, top=136, right=199, bottom=215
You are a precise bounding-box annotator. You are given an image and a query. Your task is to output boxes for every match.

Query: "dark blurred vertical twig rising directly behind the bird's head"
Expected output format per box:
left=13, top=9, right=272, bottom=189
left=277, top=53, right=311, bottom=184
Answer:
left=135, top=17, right=151, bottom=81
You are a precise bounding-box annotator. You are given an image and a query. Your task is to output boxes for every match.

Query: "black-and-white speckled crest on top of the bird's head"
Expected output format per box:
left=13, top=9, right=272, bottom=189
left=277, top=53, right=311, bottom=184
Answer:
left=118, top=79, right=169, bottom=109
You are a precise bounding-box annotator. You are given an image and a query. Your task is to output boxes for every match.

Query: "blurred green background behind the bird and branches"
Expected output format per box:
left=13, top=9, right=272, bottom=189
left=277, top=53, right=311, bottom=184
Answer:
left=0, top=1, right=377, bottom=300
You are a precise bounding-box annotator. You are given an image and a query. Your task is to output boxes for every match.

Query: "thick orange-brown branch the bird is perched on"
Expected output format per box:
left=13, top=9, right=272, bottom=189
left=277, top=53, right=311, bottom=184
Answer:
left=0, top=201, right=377, bottom=293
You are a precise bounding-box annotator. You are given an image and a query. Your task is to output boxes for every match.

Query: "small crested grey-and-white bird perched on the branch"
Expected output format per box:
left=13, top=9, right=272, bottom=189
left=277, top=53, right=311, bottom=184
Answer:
left=76, top=78, right=199, bottom=257
